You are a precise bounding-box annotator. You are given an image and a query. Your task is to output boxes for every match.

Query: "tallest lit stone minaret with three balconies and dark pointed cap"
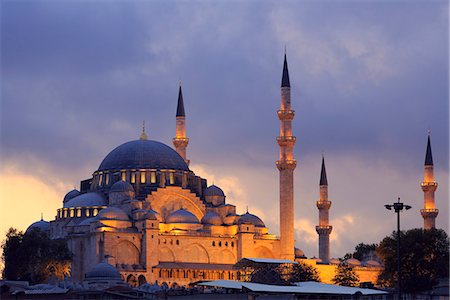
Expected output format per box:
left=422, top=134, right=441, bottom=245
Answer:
left=276, top=52, right=297, bottom=260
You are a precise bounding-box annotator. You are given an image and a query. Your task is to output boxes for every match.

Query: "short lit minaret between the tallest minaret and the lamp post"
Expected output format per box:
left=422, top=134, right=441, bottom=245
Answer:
left=316, top=156, right=333, bottom=263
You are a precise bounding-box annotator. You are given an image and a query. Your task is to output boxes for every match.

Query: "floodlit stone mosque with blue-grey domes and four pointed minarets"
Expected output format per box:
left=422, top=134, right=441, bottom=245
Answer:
left=27, top=55, right=437, bottom=286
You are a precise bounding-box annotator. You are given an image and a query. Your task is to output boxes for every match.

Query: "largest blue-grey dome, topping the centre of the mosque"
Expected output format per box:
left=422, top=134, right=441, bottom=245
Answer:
left=98, top=140, right=189, bottom=171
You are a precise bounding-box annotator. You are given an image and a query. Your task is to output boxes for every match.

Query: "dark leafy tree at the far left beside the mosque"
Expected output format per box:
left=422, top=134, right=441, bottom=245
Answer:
left=2, top=228, right=72, bottom=284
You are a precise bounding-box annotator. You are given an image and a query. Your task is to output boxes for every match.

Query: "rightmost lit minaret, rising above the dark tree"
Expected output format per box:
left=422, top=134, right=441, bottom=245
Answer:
left=420, top=132, right=439, bottom=229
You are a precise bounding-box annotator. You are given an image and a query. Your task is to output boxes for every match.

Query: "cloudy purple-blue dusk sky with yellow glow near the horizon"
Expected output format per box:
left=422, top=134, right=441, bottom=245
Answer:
left=0, top=0, right=449, bottom=257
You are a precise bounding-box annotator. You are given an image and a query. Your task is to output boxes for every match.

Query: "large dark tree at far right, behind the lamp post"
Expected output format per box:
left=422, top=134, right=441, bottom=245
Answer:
left=377, top=228, right=449, bottom=293
